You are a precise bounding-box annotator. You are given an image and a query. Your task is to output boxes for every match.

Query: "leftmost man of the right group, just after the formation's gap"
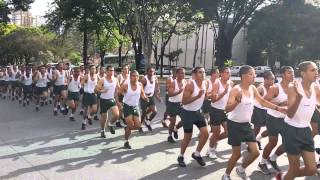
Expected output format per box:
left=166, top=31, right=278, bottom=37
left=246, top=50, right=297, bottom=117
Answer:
left=167, top=68, right=187, bottom=143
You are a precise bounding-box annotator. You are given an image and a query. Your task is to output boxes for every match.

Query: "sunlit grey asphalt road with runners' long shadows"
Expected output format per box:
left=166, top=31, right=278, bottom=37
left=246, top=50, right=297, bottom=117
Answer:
left=0, top=91, right=319, bottom=180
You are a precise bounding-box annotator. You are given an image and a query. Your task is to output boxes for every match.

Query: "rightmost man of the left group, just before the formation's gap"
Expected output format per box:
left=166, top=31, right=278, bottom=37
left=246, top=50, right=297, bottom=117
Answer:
left=139, top=68, right=161, bottom=132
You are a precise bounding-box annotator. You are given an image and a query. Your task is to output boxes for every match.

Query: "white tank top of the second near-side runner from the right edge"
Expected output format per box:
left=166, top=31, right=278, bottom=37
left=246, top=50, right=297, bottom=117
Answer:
left=228, top=85, right=254, bottom=123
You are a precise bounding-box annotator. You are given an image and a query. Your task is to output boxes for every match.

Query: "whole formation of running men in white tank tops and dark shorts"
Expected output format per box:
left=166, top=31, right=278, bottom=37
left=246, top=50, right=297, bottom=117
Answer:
left=0, top=61, right=320, bottom=180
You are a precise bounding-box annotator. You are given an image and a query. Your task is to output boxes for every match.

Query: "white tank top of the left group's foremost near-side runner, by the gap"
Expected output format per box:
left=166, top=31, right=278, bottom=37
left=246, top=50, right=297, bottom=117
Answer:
left=123, top=82, right=142, bottom=106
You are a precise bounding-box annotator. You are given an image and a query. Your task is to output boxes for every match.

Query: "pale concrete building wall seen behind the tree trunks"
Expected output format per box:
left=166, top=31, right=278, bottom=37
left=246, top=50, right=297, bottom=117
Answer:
left=158, top=25, right=247, bottom=69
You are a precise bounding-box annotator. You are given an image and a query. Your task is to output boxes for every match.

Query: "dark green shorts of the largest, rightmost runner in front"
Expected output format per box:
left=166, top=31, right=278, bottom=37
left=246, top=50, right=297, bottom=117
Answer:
left=282, top=123, right=315, bottom=155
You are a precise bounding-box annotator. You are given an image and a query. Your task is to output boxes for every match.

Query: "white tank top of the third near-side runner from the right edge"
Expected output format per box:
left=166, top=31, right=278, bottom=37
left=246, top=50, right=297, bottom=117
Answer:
left=182, top=80, right=207, bottom=111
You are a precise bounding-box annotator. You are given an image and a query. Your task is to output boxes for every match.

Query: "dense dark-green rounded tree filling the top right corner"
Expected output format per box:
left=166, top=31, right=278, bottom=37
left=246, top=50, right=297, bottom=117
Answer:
left=248, top=2, right=320, bottom=66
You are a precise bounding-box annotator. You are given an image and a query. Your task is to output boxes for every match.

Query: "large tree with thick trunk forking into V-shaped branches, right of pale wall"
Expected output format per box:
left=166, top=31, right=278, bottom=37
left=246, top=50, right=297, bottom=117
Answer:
left=190, top=0, right=265, bottom=66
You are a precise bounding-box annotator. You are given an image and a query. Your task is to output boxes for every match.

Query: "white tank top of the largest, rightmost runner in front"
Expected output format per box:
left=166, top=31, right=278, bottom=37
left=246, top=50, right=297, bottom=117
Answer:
left=284, top=82, right=317, bottom=128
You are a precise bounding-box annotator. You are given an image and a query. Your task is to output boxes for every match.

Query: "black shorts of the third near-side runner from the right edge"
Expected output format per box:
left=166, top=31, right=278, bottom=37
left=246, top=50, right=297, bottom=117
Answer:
left=181, top=108, right=207, bottom=133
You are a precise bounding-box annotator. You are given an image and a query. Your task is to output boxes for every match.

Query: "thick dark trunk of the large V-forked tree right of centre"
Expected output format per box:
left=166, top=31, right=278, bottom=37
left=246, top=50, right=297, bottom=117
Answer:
left=215, top=32, right=233, bottom=67
